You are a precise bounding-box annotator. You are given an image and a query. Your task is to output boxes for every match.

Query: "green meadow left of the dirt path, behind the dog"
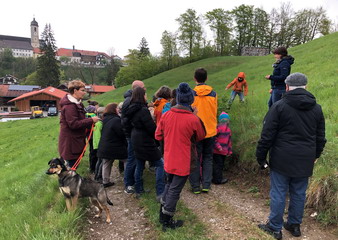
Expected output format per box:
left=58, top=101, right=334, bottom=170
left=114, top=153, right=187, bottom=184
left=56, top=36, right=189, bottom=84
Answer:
left=0, top=118, right=90, bottom=240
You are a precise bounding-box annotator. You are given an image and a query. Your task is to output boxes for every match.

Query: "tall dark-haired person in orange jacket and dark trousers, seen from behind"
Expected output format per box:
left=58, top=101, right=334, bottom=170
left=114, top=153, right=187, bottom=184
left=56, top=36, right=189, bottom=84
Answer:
left=189, top=68, right=217, bottom=194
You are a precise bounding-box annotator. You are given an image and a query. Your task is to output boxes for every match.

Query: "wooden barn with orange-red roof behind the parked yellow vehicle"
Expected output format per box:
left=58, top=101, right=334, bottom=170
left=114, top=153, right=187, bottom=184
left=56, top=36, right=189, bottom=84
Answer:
left=9, top=87, right=67, bottom=112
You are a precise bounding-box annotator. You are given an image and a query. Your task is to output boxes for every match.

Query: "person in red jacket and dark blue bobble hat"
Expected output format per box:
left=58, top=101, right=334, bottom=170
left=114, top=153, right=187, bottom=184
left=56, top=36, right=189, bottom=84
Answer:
left=155, top=83, right=206, bottom=230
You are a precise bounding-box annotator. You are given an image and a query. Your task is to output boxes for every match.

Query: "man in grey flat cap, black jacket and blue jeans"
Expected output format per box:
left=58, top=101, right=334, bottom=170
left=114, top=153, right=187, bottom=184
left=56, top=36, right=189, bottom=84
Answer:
left=256, top=73, right=326, bottom=239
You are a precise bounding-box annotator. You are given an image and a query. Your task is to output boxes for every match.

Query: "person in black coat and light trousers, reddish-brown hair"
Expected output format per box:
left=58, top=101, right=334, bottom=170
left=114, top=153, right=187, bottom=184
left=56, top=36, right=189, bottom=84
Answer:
left=97, top=103, right=128, bottom=187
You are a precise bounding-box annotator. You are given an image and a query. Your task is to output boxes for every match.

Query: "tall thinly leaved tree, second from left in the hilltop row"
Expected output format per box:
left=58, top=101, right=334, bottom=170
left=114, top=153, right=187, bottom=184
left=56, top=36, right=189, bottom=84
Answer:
left=176, top=9, right=202, bottom=62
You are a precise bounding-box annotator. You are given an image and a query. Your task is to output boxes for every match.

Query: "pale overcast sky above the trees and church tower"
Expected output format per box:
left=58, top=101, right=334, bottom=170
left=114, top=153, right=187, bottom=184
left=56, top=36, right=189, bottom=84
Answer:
left=0, top=0, right=338, bottom=57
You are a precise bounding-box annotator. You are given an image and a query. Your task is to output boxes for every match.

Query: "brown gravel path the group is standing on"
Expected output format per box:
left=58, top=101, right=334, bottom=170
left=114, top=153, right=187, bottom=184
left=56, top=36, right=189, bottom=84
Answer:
left=84, top=167, right=338, bottom=240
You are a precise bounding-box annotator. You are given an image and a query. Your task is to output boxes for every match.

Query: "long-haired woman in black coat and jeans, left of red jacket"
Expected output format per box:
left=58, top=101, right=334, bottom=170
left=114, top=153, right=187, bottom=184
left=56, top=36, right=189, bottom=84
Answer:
left=125, top=87, right=164, bottom=199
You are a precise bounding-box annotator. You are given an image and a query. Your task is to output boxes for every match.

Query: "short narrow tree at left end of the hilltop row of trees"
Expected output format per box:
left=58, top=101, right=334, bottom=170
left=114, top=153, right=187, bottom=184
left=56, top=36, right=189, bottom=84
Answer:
left=161, top=31, right=178, bottom=70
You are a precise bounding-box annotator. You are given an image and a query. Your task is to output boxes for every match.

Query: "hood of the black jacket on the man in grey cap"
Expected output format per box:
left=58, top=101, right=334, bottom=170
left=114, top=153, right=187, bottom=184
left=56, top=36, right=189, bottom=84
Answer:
left=283, top=88, right=317, bottom=111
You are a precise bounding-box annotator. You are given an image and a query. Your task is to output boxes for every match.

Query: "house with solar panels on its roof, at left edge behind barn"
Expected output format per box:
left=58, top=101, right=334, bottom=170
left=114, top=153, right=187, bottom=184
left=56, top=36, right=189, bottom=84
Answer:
left=0, top=84, right=41, bottom=112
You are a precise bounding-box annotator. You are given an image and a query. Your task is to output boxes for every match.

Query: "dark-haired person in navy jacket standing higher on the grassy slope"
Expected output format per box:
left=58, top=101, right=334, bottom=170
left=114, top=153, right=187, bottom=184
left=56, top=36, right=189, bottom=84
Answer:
left=265, top=47, right=295, bottom=108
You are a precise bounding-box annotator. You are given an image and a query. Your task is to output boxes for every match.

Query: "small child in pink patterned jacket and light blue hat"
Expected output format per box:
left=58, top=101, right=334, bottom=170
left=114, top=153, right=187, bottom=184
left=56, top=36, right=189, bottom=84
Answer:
left=212, top=112, right=232, bottom=184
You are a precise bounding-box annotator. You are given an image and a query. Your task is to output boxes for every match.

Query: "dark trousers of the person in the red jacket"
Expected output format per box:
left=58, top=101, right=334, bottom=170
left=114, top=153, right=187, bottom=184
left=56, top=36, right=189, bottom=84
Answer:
left=162, top=173, right=188, bottom=214
